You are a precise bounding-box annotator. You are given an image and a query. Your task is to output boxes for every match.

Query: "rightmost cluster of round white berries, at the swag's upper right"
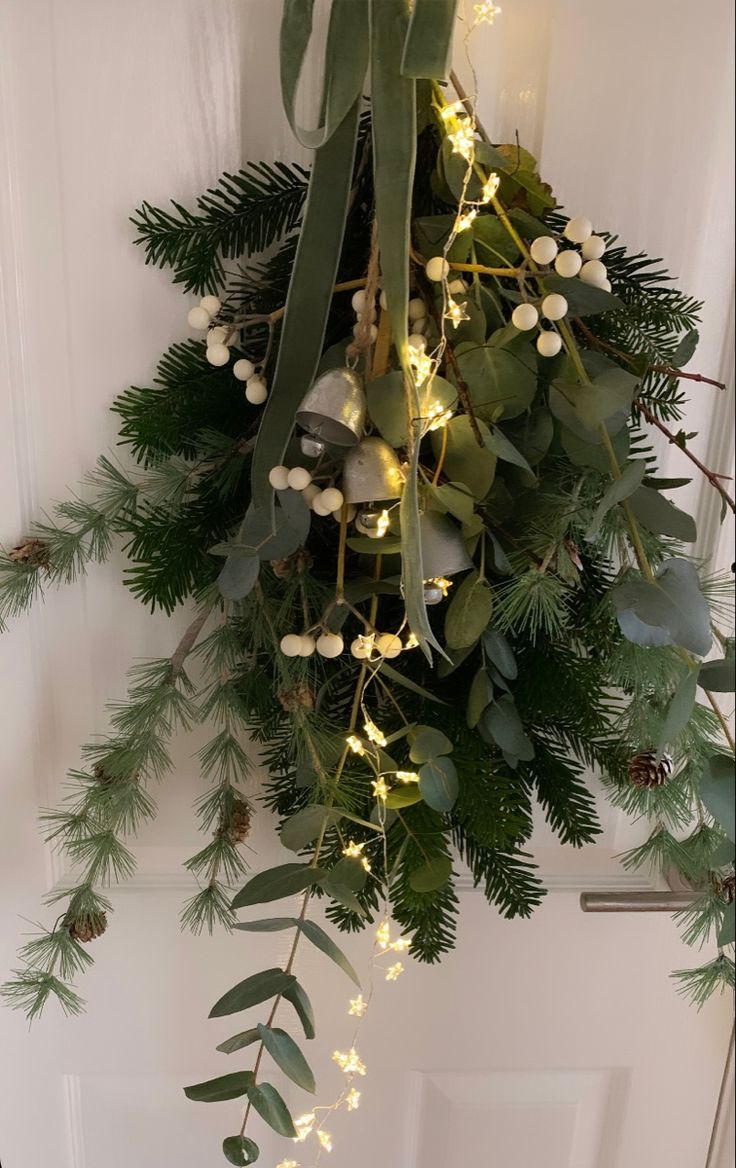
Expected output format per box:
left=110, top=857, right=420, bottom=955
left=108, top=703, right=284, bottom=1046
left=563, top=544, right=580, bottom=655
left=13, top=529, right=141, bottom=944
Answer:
left=512, top=215, right=611, bottom=357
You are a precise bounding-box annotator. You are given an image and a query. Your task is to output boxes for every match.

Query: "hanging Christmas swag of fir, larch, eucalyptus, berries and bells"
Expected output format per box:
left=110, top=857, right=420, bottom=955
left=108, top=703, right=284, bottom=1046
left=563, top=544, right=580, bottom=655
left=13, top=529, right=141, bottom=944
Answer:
left=0, top=0, right=735, bottom=1166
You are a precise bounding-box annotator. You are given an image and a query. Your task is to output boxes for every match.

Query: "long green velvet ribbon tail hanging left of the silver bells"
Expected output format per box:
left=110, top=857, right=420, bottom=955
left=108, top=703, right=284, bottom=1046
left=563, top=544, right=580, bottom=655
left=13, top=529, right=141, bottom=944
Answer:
left=251, top=97, right=361, bottom=507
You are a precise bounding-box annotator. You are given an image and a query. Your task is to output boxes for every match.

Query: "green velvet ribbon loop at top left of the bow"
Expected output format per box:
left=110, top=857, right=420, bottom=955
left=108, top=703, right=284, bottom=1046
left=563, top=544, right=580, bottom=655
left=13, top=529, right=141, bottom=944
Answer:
left=280, top=0, right=369, bottom=150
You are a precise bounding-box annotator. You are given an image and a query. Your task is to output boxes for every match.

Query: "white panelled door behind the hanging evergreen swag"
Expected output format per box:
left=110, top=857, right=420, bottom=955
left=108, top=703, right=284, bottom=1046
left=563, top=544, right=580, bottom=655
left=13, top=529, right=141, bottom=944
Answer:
left=0, top=0, right=732, bottom=1168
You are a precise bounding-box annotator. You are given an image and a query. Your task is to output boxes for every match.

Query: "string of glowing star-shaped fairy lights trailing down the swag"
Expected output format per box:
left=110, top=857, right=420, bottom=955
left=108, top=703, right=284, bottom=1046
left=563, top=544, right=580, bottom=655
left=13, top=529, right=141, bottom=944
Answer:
left=276, top=0, right=501, bottom=1168
